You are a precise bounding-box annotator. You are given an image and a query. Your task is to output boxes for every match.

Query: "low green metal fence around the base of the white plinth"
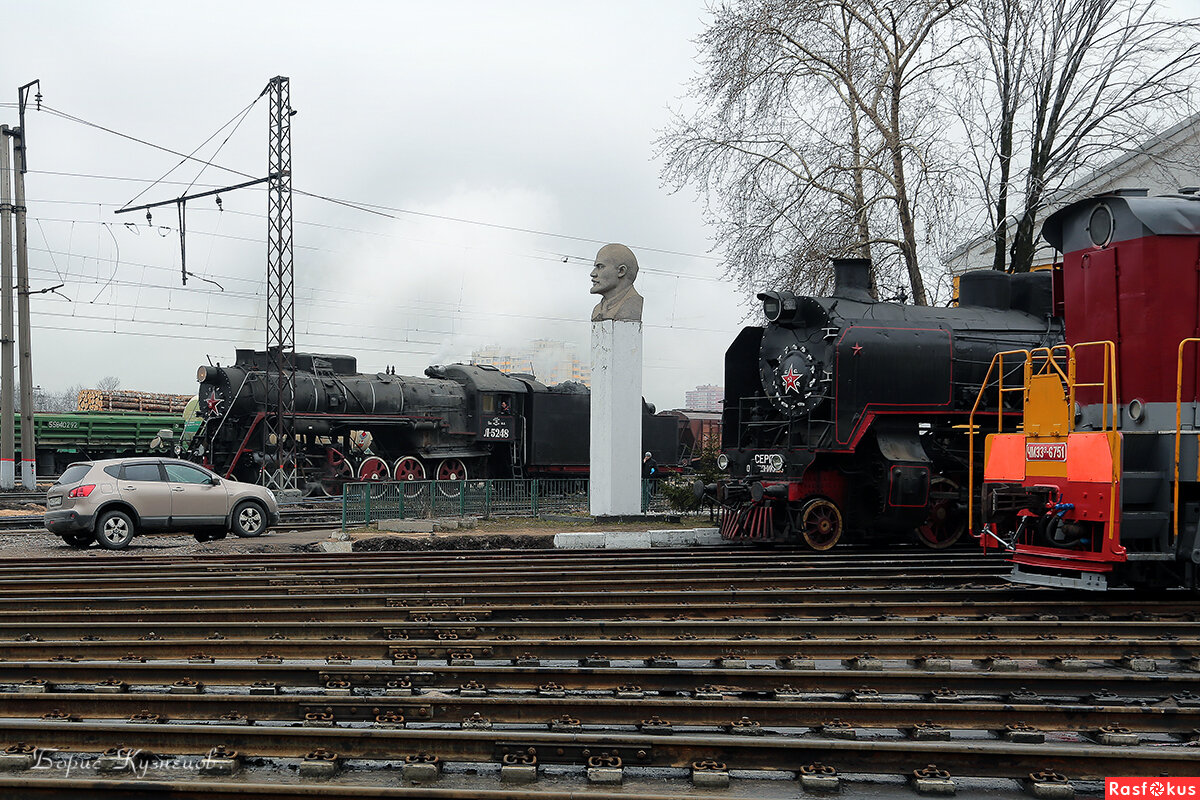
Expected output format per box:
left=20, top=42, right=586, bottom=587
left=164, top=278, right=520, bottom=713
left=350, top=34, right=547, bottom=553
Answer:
left=342, top=477, right=668, bottom=530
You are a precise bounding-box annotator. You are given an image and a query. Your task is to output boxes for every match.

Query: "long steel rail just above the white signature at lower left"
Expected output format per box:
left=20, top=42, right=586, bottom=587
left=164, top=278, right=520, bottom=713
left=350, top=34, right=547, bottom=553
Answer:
left=0, top=718, right=1195, bottom=778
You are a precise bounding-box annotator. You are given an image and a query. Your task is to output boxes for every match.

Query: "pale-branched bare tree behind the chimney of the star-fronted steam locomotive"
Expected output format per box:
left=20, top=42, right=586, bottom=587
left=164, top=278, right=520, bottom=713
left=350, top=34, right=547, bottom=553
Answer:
left=660, top=0, right=960, bottom=305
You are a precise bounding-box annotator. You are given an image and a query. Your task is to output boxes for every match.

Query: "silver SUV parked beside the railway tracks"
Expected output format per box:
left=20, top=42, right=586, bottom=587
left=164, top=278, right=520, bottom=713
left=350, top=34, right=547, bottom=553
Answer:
left=44, top=458, right=280, bottom=551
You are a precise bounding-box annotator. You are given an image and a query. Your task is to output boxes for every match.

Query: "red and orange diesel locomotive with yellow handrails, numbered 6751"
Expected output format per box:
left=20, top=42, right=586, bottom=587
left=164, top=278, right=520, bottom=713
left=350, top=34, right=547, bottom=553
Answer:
left=972, top=190, right=1200, bottom=590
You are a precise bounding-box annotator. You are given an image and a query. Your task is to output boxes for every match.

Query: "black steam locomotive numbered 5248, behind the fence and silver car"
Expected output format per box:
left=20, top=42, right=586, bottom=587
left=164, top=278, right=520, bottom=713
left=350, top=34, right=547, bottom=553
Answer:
left=187, top=349, right=679, bottom=494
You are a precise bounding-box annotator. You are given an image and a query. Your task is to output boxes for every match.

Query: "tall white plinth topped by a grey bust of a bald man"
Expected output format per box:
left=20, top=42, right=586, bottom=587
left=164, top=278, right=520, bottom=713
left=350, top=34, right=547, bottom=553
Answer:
left=590, top=245, right=642, bottom=517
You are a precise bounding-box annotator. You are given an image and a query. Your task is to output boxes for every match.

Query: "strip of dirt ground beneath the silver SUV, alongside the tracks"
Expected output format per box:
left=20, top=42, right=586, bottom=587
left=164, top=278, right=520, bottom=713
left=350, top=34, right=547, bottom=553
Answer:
left=0, top=511, right=712, bottom=559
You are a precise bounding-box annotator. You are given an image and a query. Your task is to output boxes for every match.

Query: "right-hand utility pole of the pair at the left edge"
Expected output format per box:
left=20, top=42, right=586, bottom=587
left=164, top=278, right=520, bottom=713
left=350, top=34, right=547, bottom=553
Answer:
left=12, top=80, right=42, bottom=492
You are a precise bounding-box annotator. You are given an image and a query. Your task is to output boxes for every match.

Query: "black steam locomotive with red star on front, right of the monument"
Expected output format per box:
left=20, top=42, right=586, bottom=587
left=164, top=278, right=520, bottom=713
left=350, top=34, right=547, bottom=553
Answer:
left=697, top=259, right=1062, bottom=551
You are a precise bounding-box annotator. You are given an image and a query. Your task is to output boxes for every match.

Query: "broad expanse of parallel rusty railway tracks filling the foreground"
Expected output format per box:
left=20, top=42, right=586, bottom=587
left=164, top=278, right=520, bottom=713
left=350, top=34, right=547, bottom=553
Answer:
left=0, top=549, right=1200, bottom=799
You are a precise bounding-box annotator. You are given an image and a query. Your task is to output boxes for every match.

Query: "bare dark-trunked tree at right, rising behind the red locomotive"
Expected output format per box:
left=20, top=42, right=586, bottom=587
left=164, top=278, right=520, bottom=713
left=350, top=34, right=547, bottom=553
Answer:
left=959, top=0, right=1200, bottom=272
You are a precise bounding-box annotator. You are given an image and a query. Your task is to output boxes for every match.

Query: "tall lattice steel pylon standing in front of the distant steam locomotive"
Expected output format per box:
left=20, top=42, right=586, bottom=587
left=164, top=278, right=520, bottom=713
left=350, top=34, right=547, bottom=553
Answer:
left=263, top=76, right=296, bottom=492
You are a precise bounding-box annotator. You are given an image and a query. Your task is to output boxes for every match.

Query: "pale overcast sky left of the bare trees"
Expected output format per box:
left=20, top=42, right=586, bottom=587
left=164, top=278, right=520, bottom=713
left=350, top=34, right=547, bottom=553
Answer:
left=0, top=0, right=746, bottom=408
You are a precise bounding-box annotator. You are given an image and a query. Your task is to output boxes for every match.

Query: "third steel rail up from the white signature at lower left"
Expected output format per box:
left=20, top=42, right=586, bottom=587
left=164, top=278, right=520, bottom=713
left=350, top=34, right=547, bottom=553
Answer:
left=0, top=661, right=1200, bottom=703
